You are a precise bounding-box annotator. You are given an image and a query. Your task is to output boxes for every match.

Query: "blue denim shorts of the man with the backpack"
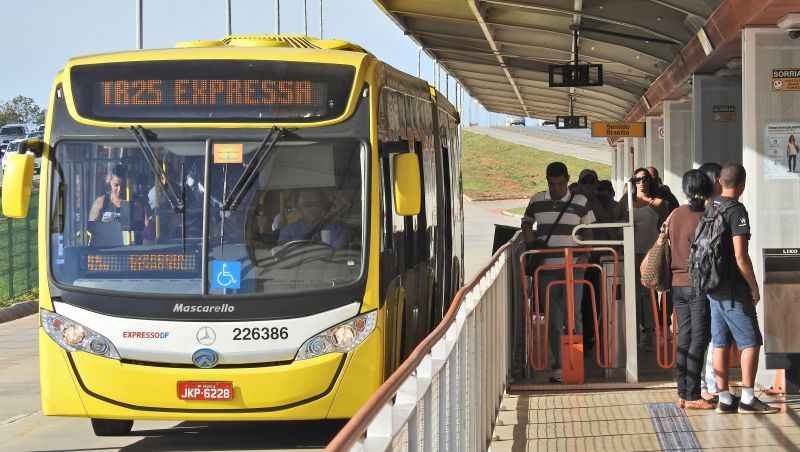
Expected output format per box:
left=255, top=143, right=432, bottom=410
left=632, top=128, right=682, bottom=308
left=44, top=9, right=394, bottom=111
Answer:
left=708, top=295, right=764, bottom=350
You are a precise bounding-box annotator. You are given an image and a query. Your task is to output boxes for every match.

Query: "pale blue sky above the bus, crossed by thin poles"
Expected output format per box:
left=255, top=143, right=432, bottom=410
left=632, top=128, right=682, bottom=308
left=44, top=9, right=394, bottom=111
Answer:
left=0, top=0, right=520, bottom=125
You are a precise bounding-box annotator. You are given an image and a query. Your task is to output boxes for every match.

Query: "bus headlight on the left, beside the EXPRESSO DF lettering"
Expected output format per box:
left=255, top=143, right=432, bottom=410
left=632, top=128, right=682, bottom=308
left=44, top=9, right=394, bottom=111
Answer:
left=39, top=309, right=119, bottom=359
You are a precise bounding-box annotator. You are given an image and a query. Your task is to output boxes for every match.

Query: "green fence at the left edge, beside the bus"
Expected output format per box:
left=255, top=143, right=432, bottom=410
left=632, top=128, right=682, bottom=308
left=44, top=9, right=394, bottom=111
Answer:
left=0, top=186, right=39, bottom=300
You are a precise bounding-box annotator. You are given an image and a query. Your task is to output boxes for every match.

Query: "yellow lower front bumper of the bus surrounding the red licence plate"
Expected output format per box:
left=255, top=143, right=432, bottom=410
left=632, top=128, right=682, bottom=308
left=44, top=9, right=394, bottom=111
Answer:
left=39, top=328, right=383, bottom=420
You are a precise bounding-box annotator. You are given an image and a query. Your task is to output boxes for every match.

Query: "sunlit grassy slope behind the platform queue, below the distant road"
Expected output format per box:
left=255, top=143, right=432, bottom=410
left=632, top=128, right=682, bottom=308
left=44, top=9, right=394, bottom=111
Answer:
left=461, top=130, right=611, bottom=200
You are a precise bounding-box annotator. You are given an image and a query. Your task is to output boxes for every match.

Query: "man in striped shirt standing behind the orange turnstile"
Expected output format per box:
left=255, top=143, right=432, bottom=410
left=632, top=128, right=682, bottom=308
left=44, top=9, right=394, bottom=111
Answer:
left=522, top=162, right=595, bottom=383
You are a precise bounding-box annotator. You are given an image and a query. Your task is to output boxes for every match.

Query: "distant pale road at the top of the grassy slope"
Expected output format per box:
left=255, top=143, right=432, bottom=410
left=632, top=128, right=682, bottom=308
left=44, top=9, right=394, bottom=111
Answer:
left=467, top=127, right=613, bottom=165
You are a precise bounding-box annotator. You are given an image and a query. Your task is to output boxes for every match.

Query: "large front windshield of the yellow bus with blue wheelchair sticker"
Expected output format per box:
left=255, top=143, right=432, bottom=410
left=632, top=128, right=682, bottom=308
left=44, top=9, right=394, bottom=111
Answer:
left=50, top=139, right=366, bottom=296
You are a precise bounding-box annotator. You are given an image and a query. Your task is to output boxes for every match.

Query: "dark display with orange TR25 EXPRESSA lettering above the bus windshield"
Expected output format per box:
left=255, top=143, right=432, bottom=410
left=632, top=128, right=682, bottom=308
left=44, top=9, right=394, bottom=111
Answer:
left=70, top=61, right=355, bottom=122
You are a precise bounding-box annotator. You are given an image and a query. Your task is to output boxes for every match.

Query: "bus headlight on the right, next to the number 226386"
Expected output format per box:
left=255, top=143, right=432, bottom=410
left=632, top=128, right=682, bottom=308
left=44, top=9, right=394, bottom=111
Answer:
left=295, top=311, right=378, bottom=361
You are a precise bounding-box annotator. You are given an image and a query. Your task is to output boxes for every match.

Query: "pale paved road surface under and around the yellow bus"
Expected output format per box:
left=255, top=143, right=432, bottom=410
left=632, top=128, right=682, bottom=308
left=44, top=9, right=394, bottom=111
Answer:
left=0, top=200, right=525, bottom=452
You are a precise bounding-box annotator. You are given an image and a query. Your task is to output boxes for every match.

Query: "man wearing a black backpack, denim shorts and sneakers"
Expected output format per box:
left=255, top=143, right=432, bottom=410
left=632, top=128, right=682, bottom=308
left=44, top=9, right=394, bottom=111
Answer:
left=689, top=163, right=778, bottom=414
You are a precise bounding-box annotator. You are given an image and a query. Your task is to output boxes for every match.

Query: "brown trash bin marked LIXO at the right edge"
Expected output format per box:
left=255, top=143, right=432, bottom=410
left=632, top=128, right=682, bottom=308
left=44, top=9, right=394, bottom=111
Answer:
left=763, top=248, right=800, bottom=394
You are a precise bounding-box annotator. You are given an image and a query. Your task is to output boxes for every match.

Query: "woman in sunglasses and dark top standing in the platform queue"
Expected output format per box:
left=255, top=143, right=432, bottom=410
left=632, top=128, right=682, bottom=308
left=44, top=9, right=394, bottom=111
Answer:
left=618, top=168, right=671, bottom=350
